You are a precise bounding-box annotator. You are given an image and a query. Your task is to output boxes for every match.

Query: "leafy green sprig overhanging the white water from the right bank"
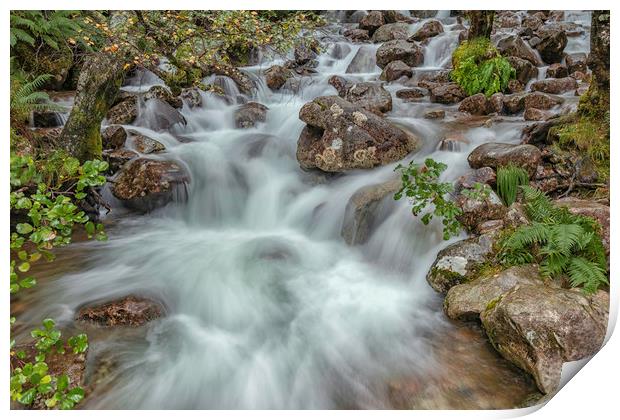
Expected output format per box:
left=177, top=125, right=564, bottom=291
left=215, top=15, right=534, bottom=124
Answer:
left=394, top=158, right=461, bottom=240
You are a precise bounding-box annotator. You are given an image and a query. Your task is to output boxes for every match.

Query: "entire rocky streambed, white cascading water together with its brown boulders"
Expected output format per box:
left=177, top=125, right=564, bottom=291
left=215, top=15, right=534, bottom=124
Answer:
left=13, top=11, right=609, bottom=409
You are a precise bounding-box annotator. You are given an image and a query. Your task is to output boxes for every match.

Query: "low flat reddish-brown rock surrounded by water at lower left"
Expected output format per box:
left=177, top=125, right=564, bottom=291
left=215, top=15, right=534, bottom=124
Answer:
left=75, top=296, right=166, bottom=327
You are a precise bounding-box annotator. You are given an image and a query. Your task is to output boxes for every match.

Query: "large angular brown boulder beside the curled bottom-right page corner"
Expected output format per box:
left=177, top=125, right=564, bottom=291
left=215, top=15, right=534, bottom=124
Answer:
left=480, top=285, right=609, bottom=394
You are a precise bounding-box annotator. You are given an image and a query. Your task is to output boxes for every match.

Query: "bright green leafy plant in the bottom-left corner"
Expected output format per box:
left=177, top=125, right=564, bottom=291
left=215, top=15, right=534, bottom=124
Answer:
left=10, top=318, right=88, bottom=410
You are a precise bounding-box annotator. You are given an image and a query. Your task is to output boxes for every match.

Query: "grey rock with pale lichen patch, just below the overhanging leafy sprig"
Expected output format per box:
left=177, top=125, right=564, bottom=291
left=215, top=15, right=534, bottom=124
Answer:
left=426, top=235, right=495, bottom=294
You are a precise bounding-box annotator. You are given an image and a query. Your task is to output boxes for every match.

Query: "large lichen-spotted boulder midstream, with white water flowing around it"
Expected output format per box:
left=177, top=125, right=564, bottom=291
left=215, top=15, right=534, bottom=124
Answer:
left=297, top=96, right=419, bottom=172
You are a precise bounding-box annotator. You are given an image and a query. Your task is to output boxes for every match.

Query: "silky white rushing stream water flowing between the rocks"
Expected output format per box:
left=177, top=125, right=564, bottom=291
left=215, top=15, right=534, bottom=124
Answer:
left=13, top=13, right=589, bottom=409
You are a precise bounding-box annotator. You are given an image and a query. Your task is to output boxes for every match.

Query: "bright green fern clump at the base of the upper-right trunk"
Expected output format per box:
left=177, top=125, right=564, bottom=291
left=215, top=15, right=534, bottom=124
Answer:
left=450, top=38, right=516, bottom=96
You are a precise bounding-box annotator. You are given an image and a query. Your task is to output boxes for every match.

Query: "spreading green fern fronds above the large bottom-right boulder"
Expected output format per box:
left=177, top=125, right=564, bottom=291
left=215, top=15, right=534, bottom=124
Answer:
left=499, top=186, right=609, bottom=294
